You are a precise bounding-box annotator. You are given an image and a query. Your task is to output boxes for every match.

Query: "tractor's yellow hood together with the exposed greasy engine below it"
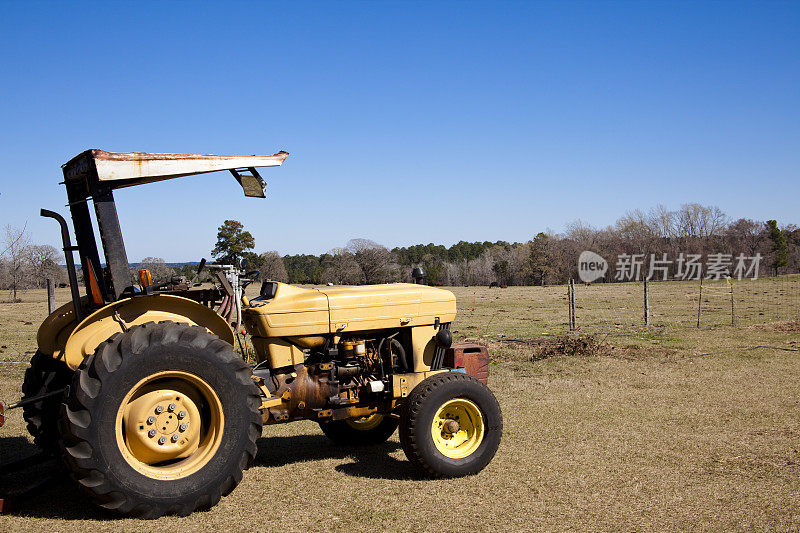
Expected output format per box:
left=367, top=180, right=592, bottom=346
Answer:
left=242, top=281, right=456, bottom=423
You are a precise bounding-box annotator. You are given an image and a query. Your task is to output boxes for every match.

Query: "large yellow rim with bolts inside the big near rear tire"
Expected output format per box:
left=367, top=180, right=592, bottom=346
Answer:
left=116, top=371, right=224, bottom=479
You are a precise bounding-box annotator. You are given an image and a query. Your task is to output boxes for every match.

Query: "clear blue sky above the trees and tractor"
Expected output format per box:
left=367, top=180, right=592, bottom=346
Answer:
left=0, top=2, right=800, bottom=262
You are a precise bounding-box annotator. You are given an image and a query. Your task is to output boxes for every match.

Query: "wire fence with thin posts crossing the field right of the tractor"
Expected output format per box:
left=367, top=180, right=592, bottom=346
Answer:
left=451, top=275, right=800, bottom=337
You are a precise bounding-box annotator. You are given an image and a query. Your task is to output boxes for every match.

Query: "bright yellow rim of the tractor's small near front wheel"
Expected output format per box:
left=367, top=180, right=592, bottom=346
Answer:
left=431, top=398, right=484, bottom=459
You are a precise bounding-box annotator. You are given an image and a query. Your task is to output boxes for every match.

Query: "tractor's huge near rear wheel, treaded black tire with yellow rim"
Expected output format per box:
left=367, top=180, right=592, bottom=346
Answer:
left=61, top=322, right=261, bottom=518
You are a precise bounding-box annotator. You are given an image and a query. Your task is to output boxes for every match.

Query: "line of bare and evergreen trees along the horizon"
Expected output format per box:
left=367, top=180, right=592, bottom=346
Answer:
left=0, top=203, right=800, bottom=301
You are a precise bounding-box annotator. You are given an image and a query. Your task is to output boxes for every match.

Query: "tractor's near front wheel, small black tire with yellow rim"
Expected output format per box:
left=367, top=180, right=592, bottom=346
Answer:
left=400, top=372, right=503, bottom=477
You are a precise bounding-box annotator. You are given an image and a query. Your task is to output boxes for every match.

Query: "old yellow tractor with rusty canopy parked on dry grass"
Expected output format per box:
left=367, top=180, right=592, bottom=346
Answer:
left=10, top=150, right=502, bottom=518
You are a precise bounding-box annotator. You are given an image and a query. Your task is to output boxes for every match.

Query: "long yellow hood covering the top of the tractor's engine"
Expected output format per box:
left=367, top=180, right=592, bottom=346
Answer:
left=244, top=283, right=456, bottom=337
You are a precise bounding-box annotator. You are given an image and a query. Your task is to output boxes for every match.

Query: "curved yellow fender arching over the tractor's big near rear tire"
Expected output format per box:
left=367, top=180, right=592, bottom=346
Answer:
left=53, top=294, right=234, bottom=370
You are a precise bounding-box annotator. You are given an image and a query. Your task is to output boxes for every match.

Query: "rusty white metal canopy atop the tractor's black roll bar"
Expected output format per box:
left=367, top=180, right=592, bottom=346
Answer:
left=63, top=149, right=289, bottom=197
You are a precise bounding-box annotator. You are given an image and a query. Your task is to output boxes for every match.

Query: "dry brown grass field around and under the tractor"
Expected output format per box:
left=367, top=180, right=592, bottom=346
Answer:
left=0, top=280, right=800, bottom=532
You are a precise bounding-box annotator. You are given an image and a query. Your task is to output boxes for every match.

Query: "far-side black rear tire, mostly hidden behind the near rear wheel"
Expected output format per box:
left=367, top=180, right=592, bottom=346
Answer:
left=22, top=351, right=73, bottom=452
